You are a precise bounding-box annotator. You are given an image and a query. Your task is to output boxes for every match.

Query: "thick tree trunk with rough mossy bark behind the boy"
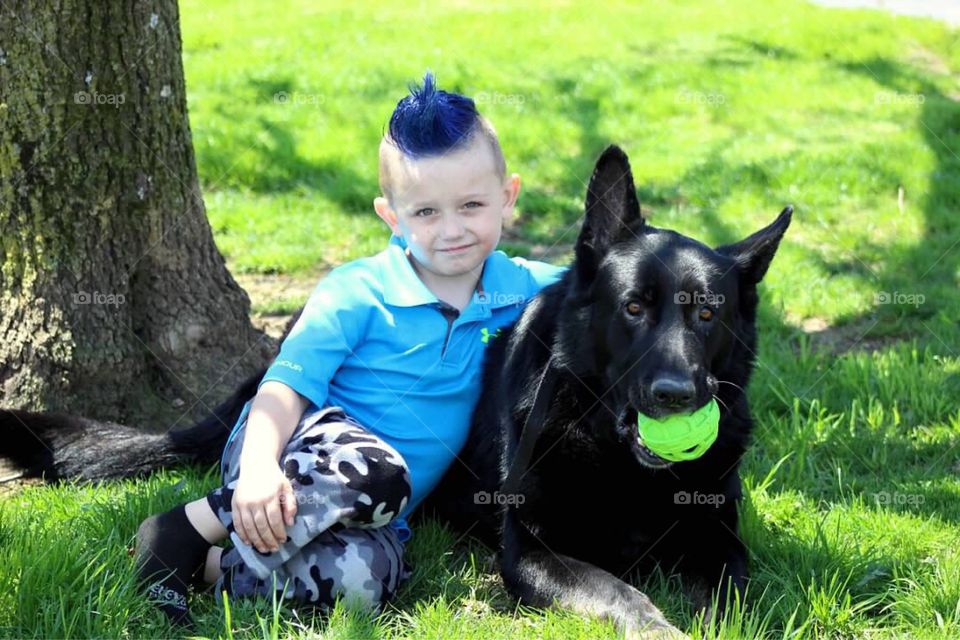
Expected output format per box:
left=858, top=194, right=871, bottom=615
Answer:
left=0, top=0, right=275, bottom=429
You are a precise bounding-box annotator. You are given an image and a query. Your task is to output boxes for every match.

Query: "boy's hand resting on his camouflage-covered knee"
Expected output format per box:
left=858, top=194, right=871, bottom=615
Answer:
left=230, top=458, right=297, bottom=553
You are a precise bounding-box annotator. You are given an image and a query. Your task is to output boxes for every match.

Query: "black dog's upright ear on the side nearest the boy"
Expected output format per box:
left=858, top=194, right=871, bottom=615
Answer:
left=576, top=145, right=643, bottom=280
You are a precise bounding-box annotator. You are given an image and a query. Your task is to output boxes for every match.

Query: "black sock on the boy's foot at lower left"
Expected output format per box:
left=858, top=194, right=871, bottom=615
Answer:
left=136, top=505, right=211, bottom=626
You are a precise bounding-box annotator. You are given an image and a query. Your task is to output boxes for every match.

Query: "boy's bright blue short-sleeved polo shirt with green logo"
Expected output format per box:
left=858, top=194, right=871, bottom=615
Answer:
left=221, top=236, right=565, bottom=541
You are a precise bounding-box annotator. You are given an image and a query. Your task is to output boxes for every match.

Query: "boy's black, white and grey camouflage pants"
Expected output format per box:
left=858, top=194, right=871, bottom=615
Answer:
left=207, top=404, right=410, bottom=611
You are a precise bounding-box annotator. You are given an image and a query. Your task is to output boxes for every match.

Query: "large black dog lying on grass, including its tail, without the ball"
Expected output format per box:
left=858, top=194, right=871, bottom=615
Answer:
left=0, top=147, right=792, bottom=632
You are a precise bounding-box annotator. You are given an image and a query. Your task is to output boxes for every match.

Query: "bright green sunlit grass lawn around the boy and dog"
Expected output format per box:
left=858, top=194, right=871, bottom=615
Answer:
left=0, top=0, right=960, bottom=638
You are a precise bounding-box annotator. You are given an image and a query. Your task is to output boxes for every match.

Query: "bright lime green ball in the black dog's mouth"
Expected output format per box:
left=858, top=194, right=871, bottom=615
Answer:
left=637, top=400, right=720, bottom=462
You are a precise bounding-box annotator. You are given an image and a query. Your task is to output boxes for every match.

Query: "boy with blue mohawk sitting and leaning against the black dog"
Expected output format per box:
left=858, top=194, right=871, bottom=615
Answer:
left=137, top=73, right=563, bottom=624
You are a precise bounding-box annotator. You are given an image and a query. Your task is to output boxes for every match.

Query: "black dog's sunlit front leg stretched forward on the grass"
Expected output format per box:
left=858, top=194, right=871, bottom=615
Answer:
left=500, top=509, right=685, bottom=638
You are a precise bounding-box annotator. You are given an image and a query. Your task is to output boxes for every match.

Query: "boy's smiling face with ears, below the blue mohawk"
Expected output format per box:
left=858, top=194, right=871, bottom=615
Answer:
left=374, top=135, right=520, bottom=279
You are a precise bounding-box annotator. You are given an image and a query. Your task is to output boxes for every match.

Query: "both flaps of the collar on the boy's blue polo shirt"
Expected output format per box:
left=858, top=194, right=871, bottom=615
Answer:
left=381, top=235, right=527, bottom=308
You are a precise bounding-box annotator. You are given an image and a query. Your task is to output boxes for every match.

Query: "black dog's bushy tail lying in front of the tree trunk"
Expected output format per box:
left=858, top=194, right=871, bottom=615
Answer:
left=0, top=369, right=266, bottom=482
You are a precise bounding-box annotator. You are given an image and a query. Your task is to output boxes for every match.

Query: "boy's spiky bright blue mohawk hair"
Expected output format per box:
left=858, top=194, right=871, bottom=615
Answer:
left=390, top=71, right=480, bottom=158
